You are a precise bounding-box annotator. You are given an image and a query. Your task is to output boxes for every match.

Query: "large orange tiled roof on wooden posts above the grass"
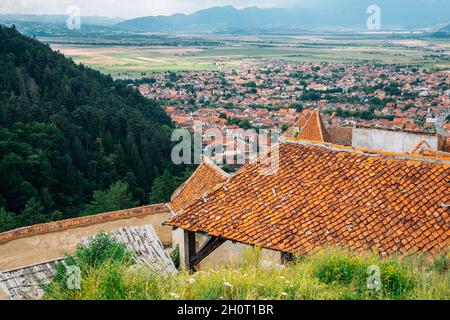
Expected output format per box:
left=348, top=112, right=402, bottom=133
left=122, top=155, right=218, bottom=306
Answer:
left=169, top=142, right=450, bottom=254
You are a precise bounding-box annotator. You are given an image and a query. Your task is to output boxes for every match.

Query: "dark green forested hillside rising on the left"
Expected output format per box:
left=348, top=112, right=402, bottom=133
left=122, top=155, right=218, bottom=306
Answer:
left=0, top=26, right=177, bottom=231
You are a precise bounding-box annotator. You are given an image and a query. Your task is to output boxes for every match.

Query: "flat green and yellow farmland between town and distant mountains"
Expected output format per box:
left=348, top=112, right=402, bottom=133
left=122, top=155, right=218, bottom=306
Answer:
left=52, top=36, right=450, bottom=78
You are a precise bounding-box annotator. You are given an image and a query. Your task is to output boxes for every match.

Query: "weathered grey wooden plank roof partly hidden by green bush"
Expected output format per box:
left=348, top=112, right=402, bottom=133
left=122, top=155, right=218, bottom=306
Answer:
left=0, top=225, right=177, bottom=300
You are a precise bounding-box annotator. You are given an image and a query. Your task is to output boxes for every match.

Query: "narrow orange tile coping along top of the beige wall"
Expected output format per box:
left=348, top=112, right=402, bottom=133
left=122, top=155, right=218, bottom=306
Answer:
left=0, top=204, right=169, bottom=243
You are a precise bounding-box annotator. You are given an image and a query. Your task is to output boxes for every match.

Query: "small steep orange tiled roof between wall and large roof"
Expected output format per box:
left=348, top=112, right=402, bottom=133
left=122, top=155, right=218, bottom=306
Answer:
left=169, top=158, right=230, bottom=212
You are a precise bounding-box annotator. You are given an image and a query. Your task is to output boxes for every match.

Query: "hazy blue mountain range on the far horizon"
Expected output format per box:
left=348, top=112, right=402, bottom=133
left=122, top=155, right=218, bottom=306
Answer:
left=116, top=0, right=450, bottom=33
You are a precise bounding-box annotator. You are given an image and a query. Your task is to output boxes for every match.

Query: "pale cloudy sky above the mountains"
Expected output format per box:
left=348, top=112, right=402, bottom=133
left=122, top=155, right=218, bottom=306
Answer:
left=0, top=0, right=317, bottom=18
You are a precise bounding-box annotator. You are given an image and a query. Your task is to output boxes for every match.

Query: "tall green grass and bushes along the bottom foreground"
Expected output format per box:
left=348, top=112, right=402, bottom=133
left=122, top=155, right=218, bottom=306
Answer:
left=45, top=238, right=450, bottom=300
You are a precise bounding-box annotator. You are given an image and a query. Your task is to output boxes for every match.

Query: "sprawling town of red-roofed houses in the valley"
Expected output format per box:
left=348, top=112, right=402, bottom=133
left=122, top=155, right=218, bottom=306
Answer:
left=139, top=60, right=450, bottom=132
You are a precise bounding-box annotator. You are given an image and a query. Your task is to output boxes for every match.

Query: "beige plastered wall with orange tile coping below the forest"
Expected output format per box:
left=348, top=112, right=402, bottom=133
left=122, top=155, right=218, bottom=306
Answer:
left=0, top=205, right=172, bottom=272
